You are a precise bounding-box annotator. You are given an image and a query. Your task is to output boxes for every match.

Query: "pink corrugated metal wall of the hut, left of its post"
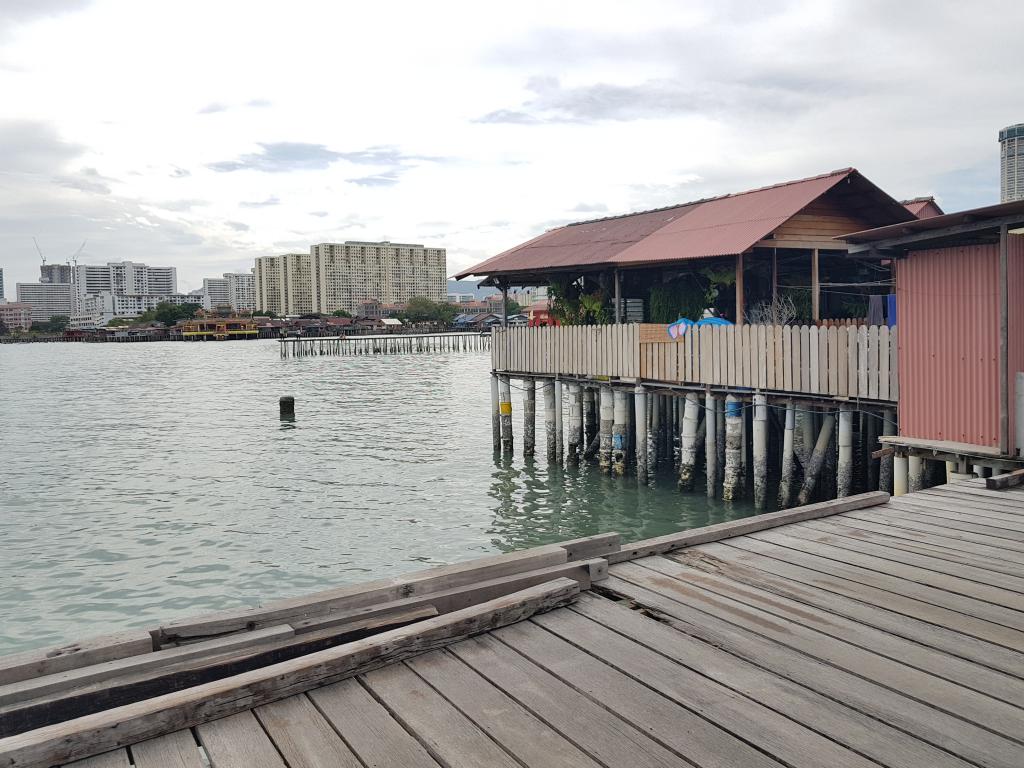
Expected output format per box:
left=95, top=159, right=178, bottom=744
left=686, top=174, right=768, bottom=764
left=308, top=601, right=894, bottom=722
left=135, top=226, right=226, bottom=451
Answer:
left=896, top=245, right=999, bottom=447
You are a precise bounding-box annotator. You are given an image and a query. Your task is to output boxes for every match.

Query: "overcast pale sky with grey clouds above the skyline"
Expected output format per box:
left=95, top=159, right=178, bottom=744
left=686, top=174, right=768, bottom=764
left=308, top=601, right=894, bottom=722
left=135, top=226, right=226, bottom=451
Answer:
left=0, top=0, right=1024, bottom=299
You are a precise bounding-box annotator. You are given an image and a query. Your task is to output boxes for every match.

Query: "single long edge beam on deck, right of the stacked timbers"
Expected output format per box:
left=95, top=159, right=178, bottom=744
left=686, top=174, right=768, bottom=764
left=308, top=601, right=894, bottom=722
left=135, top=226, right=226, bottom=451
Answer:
left=607, top=490, right=889, bottom=563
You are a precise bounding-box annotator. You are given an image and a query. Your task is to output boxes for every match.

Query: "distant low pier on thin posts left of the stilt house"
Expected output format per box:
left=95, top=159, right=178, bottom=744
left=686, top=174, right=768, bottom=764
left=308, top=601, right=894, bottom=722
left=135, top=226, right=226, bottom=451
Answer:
left=281, top=331, right=490, bottom=358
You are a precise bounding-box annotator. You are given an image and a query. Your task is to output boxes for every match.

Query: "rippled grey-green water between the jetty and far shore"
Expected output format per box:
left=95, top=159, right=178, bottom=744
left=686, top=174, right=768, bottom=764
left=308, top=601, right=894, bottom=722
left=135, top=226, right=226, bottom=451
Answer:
left=0, top=341, right=751, bottom=653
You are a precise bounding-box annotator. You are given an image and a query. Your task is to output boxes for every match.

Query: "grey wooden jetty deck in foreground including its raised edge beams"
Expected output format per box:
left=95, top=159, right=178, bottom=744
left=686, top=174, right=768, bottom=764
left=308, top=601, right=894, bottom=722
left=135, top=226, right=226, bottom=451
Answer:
left=0, top=478, right=1024, bottom=768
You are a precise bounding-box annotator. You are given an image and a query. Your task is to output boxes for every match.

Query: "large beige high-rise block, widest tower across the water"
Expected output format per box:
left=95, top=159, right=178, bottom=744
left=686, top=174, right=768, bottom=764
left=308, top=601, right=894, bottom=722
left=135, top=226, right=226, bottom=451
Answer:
left=309, top=241, right=446, bottom=313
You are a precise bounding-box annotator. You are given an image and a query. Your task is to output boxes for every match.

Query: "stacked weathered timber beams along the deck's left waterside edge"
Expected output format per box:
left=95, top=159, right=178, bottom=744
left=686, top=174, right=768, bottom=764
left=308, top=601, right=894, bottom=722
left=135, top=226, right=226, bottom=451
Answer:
left=0, top=534, right=621, bottom=768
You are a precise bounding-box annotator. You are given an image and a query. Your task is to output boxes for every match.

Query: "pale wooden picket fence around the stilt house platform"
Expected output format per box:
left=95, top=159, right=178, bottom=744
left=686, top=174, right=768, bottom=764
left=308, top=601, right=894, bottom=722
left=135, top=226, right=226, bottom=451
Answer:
left=492, top=324, right=899, bottom=400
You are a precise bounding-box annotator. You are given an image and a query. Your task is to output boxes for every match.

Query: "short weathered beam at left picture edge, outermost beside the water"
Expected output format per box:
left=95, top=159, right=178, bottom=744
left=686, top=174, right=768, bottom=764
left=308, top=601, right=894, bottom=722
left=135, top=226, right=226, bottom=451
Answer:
left=0, top=630, right=153, bottom=685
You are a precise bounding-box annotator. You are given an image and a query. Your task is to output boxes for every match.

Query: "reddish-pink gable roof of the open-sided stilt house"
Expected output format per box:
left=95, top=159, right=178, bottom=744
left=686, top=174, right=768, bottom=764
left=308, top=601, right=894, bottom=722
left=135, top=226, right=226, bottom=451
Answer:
left=456, top=168, right=914, bottom=280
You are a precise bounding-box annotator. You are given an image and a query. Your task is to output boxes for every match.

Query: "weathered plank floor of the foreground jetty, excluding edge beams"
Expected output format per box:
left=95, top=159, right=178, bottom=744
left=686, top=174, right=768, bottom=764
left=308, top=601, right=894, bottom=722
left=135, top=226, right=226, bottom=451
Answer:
left=64, top=482, right=1024, bottom=768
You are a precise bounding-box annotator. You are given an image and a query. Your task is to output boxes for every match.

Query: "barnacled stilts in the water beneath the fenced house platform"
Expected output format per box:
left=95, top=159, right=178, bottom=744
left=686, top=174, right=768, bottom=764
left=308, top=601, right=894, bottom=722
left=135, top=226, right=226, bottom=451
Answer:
left=490, top=373, right=906, bottom=509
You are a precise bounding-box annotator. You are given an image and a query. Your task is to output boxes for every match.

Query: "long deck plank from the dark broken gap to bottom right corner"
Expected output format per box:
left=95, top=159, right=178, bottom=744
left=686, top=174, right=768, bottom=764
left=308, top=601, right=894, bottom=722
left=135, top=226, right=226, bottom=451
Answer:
left=608, top=563, right=1019, bottom=768
